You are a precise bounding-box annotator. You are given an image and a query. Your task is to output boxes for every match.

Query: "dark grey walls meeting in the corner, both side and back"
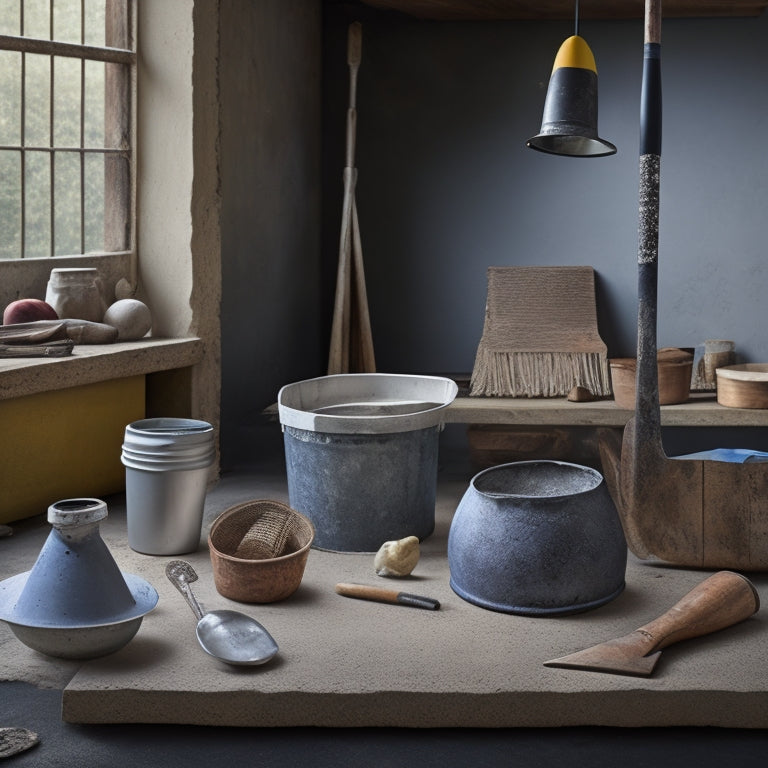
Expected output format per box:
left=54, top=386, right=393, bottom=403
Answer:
left=220, top=0, right=768, bottom=468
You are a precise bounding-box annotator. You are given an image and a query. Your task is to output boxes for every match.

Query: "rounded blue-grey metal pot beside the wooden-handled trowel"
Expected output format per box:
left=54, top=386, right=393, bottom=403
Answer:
left=448, top=461, right=627, bottom=616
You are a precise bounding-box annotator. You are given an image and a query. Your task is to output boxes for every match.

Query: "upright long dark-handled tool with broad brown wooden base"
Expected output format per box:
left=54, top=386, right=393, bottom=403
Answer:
left=600, top=0, right=768, bottom=571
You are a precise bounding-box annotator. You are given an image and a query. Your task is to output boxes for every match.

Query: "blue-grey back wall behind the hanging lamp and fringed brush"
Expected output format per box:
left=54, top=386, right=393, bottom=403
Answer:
left=330, top=9, right=768, bottom=372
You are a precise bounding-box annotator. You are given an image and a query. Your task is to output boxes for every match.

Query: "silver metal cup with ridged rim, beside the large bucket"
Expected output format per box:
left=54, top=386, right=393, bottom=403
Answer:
left=121, top=418, right=216, bottom=555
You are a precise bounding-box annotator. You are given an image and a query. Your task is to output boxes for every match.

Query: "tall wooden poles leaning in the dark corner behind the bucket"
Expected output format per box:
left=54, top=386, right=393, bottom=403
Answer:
left=328, top=22, right=376, bottom=374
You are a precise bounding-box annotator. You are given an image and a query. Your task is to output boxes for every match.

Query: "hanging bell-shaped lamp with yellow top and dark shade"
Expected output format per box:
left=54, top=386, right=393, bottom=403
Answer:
left=526, top=0, right=616, bottom=157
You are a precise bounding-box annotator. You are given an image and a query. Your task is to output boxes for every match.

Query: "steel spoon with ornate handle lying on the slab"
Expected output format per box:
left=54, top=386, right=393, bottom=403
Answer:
left=165, top=560, right=278, bottom=665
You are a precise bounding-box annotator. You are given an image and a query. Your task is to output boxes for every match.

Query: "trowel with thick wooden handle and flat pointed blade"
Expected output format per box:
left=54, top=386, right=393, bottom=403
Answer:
left=544, top=571, right=760, bottom=677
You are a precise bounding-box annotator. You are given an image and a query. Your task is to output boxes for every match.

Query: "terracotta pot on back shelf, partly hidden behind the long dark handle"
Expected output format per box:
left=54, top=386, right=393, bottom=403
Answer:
left=609, top=348, right=693, bottom=410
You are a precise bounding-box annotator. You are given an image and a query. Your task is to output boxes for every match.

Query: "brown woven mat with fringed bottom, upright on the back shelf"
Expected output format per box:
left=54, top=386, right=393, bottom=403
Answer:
left=470, top=267, right=611, bottom=397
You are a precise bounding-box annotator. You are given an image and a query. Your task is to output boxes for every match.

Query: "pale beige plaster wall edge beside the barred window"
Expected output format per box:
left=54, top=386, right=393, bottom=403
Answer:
left=137, top=0, right=221, bottom=432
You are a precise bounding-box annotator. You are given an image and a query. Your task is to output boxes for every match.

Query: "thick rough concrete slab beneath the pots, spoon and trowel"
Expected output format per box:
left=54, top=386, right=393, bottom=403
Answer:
left=0, top=460, right=768, bottom=728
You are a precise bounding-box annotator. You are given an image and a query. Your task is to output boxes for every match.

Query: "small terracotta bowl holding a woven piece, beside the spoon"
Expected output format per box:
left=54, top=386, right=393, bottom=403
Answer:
left=208, top=499, right=315, bottom=603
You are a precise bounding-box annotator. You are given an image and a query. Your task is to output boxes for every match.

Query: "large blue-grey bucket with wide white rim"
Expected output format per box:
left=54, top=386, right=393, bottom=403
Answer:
left=278, top=373, right=458, bottom=552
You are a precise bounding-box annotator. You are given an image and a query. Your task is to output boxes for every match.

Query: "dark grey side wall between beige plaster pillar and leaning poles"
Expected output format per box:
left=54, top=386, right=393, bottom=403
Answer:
left=219, top=0, right=324, bottom=467
